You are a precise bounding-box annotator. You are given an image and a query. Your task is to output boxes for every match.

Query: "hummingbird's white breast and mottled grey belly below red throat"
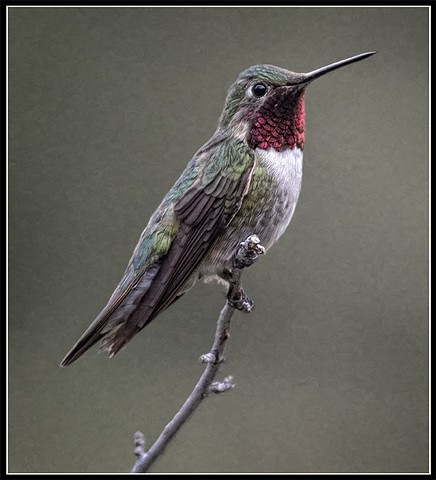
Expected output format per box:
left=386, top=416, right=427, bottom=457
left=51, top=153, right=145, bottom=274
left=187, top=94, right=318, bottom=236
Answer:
left=201, top=148, right=303, bottom=276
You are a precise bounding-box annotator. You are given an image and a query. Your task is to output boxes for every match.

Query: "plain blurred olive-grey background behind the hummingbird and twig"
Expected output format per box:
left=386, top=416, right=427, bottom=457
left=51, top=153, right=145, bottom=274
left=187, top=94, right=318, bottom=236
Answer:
left=8, top=7, right=429, bottom=472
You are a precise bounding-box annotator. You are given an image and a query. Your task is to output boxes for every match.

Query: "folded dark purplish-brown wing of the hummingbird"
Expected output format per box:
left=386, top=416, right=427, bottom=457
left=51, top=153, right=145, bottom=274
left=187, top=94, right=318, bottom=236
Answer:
left=105, top=150, right=254, bottom=355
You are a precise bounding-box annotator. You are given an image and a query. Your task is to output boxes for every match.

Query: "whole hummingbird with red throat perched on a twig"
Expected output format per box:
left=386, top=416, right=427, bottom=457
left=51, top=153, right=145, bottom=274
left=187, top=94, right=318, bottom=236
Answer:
left=61, top=51, right=376, bottom=367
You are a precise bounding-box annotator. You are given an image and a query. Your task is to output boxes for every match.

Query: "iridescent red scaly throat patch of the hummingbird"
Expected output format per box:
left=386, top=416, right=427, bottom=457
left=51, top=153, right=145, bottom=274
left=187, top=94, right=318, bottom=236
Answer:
left=248, top=88, right=304, bottom=152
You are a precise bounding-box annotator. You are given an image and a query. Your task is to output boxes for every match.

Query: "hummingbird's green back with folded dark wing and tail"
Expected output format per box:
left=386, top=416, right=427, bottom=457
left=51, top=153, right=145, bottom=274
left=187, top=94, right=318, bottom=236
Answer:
left=61, top=136, right=254, bottom=366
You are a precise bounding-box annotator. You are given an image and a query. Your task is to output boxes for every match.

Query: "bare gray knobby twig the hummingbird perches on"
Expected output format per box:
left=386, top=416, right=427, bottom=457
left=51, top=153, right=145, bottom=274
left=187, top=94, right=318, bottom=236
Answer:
left=132, top=235, right=265, bottom=473
